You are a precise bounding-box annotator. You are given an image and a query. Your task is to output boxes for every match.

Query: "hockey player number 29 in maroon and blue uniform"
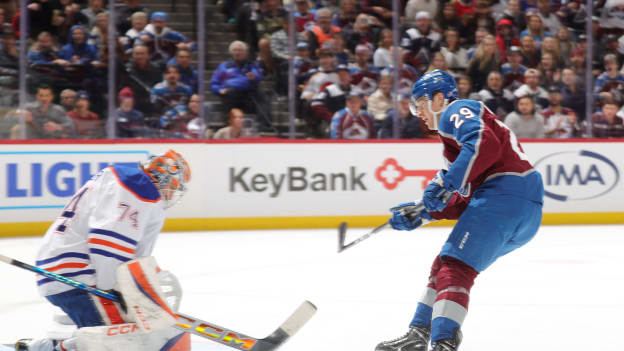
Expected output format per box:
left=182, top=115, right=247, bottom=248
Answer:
left=375, top=70, right=544, bottom=351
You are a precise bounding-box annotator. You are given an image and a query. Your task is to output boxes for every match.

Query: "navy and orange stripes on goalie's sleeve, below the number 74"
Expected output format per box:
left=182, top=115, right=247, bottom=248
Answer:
left=87, top=228, right=138, bottom=262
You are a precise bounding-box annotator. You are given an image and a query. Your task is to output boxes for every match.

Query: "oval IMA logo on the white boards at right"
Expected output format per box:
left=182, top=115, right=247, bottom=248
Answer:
left=535, top=150, right=620, bottom=201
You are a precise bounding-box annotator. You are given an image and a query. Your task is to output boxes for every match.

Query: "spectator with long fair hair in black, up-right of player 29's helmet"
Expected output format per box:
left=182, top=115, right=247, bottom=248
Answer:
left=466, top=35, right=503, bottom=91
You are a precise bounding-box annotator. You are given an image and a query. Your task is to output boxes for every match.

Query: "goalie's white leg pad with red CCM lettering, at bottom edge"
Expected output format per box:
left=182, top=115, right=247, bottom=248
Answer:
left=76, top=323, right=191, bottom=351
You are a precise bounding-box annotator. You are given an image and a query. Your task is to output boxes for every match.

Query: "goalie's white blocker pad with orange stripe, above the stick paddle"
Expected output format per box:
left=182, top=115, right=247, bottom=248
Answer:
left=117, top=257, right=177, bottom=332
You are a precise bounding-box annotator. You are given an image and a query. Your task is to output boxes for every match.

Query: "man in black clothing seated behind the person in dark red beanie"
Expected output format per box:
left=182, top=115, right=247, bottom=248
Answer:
left=119, top=44, right=162, bottom=117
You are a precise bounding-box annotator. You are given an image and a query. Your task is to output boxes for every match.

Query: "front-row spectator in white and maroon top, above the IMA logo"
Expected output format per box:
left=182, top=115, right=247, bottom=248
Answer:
left=542, top=86, right=581, bottom=139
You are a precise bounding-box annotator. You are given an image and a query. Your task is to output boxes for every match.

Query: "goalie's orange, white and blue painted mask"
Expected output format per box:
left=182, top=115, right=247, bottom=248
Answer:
left=141, top=150, right=191, bottom=208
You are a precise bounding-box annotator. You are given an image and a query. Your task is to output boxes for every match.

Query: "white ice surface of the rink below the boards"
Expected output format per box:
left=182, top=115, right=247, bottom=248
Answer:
left=0, top=226, right=624, bottom=351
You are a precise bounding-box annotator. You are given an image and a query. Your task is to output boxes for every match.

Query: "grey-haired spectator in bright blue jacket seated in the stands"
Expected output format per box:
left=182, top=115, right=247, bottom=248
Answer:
left=210, top=41, right=270, bottom=126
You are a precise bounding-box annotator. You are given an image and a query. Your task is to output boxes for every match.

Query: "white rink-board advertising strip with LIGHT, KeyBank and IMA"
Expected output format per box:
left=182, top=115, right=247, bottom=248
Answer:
left=0, top=142, right=624, bottom=226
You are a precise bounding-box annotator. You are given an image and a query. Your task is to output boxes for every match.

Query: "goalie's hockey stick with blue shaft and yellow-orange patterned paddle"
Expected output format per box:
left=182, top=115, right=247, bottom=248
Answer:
left=0, top=255, right=316, bottom=351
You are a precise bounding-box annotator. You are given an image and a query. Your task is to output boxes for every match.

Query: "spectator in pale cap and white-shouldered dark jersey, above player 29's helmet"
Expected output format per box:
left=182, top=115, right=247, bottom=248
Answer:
left=401, top=11, right=442, bottom=71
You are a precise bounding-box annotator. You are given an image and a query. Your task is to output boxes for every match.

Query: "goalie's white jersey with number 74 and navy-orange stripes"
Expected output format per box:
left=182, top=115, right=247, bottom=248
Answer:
left=36, top=166, right=165, bottom=296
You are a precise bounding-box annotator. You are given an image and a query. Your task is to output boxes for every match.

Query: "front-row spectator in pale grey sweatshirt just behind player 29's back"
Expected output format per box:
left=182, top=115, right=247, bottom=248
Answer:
left=505, top=96, right=544, bottom=139
